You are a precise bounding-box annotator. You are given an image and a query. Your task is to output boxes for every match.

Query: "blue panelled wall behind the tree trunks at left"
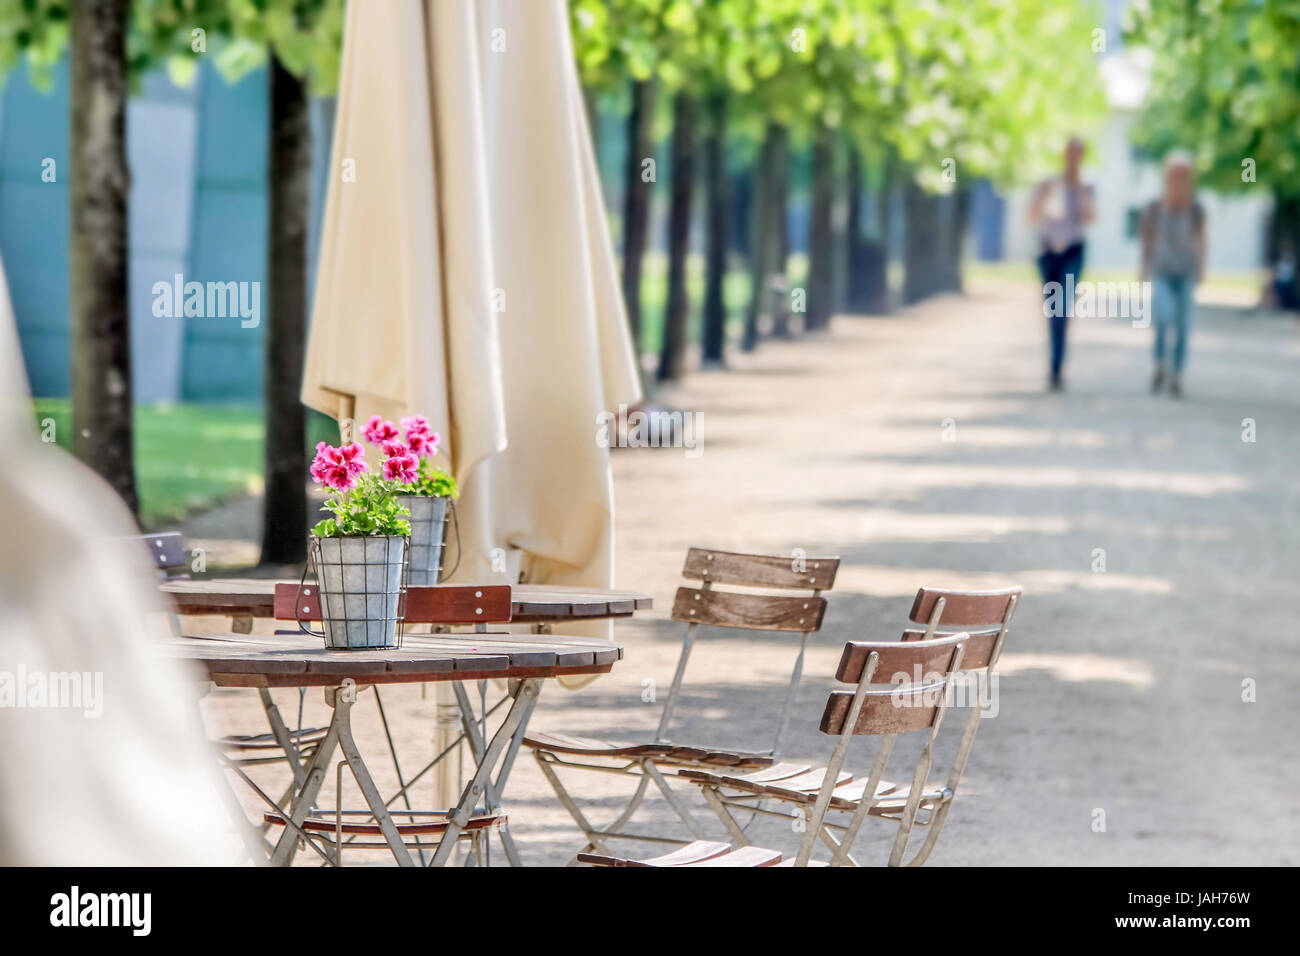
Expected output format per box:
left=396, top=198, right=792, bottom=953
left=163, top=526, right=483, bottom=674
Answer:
left=0, top=53, right=333, bottom=403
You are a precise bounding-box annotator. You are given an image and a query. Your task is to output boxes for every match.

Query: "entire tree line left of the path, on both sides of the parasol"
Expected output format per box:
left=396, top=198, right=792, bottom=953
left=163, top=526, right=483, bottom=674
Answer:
left=0, top=0, right=1100, bottom=562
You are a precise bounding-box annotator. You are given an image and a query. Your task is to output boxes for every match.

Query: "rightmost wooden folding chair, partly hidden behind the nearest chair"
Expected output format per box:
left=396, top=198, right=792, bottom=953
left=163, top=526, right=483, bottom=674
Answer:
left=679, top=588, right=1022, bottom=865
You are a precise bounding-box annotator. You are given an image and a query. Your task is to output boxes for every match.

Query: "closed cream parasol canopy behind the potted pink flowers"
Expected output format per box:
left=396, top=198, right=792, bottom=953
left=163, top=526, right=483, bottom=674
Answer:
left=303, top=0, right=640, bottom=613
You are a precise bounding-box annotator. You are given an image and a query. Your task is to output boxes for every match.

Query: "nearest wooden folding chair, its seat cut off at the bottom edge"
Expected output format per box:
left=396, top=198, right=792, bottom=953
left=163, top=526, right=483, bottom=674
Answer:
left=579, top=633, right=969, bottom=866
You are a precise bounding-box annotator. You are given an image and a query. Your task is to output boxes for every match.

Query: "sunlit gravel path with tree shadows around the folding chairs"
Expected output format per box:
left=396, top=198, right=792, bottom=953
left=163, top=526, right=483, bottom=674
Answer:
left=195, top=284, right=1300, bottom=865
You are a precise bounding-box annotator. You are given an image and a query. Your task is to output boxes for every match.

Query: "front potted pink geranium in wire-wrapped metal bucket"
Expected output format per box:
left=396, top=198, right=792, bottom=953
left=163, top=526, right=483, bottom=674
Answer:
left=311, top=441, right=419, bottom=648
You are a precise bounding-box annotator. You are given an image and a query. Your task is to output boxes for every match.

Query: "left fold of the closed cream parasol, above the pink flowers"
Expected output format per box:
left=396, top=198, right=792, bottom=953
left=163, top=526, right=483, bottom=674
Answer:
left=303, top=3, right=506, bottom=504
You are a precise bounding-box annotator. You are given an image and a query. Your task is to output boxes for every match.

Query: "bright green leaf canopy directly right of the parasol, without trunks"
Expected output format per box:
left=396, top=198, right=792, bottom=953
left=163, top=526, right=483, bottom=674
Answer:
left=571, top=0, right=1105, bottom=187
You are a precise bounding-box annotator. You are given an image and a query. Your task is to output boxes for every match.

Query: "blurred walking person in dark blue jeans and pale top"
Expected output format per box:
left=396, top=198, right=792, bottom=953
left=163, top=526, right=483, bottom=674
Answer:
left=1030, top=137, right=1096, bottom=392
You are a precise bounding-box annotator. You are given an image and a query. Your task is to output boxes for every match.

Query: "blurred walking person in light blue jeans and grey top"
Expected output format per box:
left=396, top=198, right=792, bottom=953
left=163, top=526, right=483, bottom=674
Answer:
left=1141, top=151, right=1205, bottom=398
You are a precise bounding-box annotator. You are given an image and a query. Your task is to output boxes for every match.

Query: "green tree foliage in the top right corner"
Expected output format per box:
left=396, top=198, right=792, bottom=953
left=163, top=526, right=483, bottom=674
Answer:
left=1128, top=0, right=1300, bottom=196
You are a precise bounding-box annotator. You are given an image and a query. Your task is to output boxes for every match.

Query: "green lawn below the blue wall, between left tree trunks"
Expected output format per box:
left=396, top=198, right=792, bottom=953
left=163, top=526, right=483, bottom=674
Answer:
left=33, top=398, right=338, bottom=527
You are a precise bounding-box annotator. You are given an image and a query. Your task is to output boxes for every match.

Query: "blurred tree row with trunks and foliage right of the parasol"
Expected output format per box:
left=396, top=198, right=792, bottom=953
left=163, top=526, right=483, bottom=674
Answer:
left=571, top=0, right=1104, bottom=381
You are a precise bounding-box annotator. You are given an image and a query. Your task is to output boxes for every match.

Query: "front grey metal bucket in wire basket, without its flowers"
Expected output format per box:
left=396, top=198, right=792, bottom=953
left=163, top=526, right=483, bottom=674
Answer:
left=311, top=535, right=410, bottom=649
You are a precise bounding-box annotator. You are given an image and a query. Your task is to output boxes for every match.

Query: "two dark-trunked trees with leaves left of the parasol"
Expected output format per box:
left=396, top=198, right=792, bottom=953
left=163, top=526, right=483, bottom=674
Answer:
left=0, top=0, right=343, bottom=563
